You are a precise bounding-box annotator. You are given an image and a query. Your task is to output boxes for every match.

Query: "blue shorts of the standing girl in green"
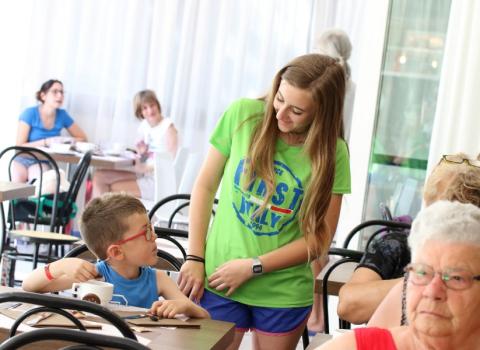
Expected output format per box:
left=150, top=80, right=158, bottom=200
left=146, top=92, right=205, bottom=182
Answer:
left=200, top=289, right=312, bottom=335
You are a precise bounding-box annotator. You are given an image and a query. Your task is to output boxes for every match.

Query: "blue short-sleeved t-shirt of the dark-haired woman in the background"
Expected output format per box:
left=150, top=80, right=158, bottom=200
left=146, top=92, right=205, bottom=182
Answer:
left=19, top=106, right=74, bottom=142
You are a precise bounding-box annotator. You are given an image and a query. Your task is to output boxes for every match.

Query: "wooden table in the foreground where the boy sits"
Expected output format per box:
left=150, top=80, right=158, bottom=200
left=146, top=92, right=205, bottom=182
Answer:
left=0, top=287, right=235, bottom=350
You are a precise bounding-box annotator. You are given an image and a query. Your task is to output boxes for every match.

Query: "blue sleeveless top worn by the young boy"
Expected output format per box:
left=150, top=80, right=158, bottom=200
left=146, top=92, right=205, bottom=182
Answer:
left=95, top=261, right=158, bottom=309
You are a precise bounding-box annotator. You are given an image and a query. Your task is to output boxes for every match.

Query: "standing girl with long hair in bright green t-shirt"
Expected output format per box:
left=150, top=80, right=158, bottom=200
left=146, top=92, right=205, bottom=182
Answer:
left=179, top=54, right=350, bottom=349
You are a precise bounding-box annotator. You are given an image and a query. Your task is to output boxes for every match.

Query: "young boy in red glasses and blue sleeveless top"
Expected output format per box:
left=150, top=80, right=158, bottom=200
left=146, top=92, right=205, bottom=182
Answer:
left=22, top=193, right=210, bottom=318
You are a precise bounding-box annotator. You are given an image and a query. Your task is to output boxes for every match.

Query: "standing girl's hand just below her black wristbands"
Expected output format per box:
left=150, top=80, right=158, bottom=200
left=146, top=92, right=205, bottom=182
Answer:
left=177, top=261, right=205, bottom=302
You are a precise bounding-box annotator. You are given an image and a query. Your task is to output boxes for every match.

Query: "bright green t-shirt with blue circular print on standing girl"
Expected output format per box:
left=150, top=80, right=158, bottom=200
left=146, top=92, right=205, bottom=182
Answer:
left=205, top=99, right=350, bottom=307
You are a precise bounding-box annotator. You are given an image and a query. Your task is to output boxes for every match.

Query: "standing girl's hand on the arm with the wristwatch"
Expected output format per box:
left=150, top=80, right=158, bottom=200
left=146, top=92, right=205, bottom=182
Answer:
left=208, top=259, right=253, bottom=296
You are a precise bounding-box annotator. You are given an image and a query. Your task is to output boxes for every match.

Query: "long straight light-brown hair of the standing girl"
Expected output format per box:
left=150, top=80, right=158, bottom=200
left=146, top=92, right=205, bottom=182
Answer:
left=247, top=54, right=345, bottom=257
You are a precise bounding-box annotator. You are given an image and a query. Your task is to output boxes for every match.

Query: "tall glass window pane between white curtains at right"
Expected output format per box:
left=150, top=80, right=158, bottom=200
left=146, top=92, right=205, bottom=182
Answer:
left=363, top=0, right=450, bottom=224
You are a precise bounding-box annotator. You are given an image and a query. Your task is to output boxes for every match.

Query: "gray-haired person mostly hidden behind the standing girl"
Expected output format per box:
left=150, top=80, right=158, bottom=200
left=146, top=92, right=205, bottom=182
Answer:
left=313, top=28, right=355, bottom=143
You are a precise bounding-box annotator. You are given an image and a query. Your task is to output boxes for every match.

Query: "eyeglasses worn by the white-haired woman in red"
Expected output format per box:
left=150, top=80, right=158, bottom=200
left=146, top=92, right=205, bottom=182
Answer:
left=405, top=263, right=480, bottom=290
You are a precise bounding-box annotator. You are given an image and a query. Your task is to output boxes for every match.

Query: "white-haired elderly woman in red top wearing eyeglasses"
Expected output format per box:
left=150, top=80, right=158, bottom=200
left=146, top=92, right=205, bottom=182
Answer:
left=319, top=201, right=480, bottom=350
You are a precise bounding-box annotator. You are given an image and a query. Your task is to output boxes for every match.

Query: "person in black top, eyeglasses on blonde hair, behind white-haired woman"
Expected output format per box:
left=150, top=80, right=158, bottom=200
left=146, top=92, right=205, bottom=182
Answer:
left=337, top=153, right=480, bottom=327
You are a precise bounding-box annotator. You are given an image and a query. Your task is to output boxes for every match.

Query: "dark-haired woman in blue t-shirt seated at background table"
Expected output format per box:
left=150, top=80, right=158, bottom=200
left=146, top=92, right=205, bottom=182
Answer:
left=12, top=79, right=87, bottom=182
